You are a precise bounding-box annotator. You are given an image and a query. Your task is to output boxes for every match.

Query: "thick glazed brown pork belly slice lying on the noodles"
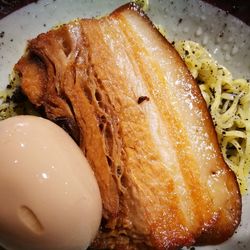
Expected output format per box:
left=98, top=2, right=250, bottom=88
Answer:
left=15, top=4, right=241, bottom=249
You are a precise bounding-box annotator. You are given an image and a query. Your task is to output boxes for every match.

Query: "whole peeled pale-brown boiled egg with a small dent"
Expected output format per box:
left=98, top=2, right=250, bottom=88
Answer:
left=0, top=116, right=102, bottom=250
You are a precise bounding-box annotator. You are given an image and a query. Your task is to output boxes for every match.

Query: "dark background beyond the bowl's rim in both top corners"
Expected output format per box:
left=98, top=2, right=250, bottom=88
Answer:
left=0, top=0, right=250, bottom=25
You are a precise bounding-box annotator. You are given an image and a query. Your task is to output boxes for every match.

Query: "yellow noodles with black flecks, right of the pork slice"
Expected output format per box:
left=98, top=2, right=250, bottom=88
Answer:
left=175, top=41, right=250, bottom=194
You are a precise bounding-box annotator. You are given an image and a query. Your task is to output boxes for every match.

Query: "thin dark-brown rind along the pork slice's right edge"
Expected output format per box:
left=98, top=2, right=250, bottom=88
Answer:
left=111, top=2, right=242, bottom=245
